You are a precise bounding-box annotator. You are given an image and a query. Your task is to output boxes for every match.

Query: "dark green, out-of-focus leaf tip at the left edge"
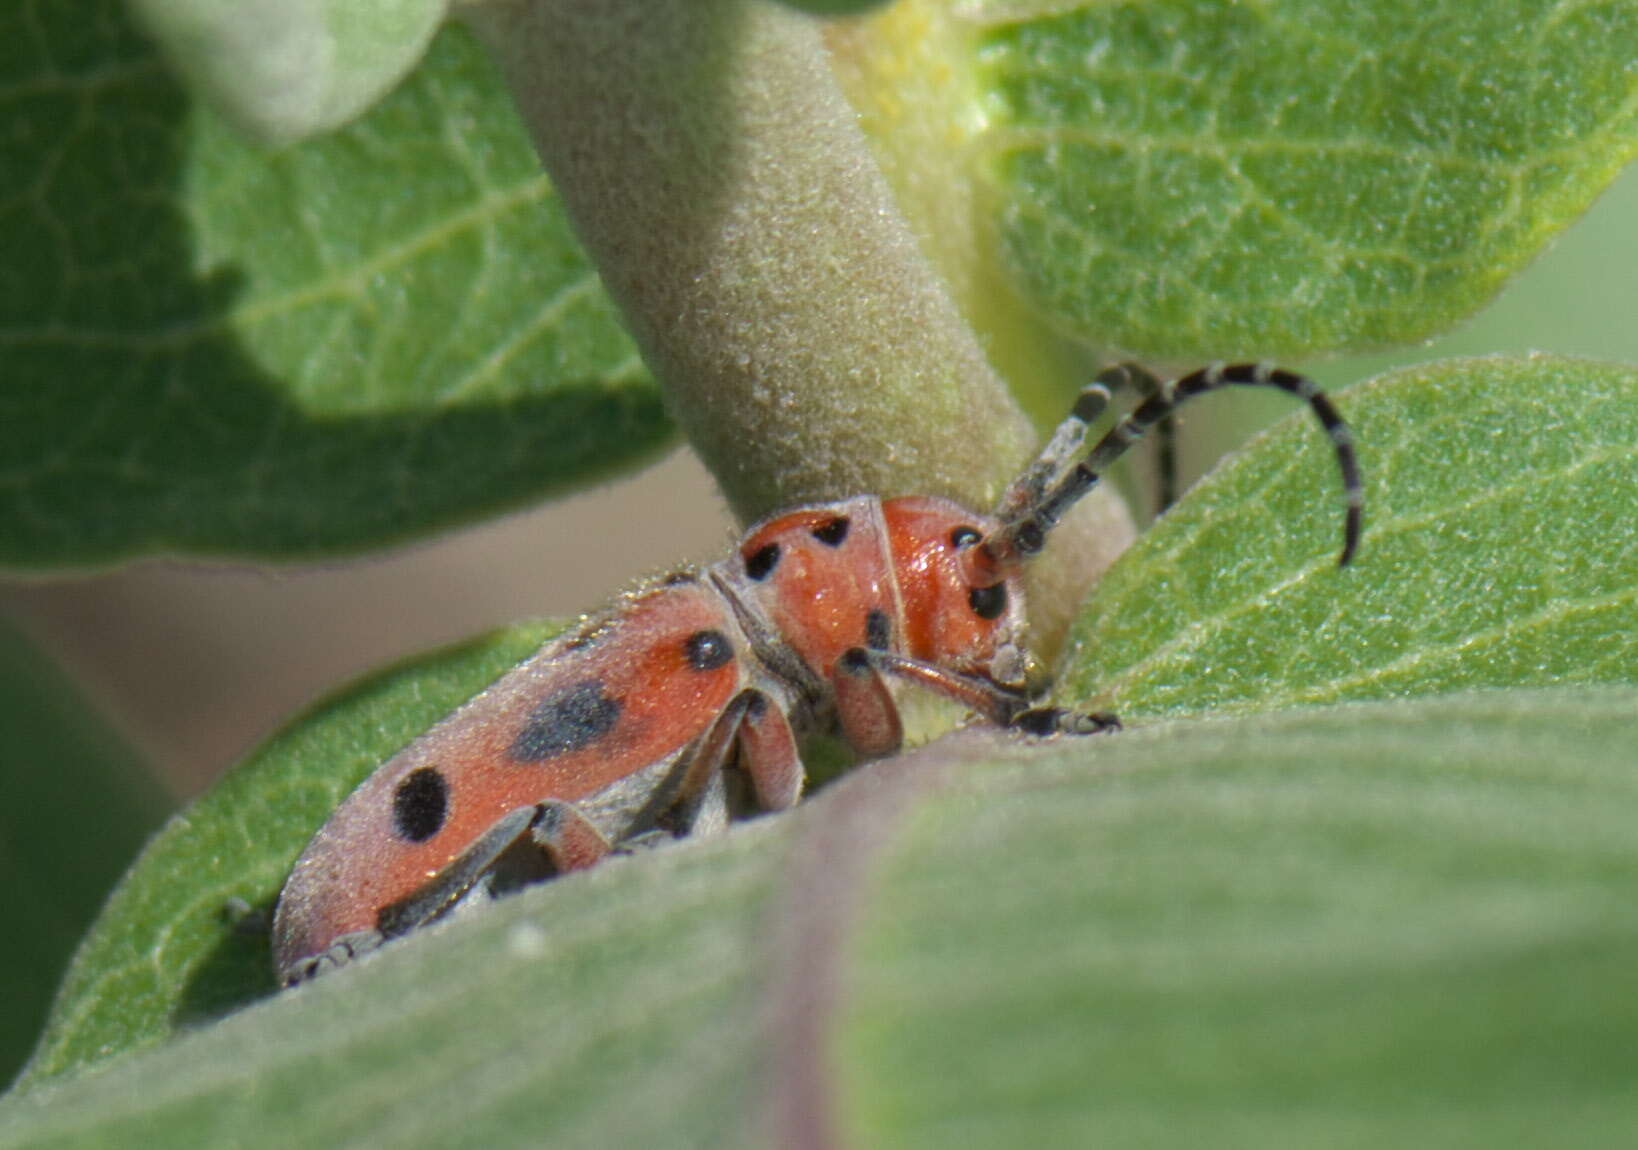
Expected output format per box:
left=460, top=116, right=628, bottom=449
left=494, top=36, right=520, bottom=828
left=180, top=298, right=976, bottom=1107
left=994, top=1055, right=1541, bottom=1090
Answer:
left=0, top=621, right=165, bottom=1083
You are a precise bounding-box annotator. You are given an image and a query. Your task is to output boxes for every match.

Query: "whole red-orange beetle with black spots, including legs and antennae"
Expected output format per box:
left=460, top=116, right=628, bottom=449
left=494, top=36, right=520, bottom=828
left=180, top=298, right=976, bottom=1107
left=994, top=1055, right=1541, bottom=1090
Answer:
left=274, top=364, right=1363, bottom=985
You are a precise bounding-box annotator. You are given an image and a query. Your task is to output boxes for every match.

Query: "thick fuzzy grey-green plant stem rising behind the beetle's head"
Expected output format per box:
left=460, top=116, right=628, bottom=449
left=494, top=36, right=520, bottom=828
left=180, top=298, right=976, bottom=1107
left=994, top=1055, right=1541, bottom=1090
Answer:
left=465, top=0, right=1130, bottom=648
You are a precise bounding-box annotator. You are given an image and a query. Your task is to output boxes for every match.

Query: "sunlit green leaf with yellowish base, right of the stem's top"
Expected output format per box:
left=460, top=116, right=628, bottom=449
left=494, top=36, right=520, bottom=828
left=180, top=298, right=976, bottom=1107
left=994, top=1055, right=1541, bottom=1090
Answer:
left=842, top=0, right=1638, bottom=365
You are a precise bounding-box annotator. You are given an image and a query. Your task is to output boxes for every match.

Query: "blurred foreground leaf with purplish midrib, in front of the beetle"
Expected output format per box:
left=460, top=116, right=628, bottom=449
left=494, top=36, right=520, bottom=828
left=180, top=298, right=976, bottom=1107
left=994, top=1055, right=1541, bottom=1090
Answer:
left=0, top=690, right=1638, bottom=1147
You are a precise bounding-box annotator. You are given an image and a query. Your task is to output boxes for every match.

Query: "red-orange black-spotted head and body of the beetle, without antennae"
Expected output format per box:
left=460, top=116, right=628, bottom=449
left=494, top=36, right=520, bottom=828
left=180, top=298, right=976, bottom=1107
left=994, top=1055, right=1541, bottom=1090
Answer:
left=275, top=496, right=1022, bottom=978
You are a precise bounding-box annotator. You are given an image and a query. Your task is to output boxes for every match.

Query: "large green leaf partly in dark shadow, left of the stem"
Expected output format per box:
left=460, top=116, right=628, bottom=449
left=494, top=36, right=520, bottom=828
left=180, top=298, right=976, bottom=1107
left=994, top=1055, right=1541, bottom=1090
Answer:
left=0, top=0, right=670, bottom=568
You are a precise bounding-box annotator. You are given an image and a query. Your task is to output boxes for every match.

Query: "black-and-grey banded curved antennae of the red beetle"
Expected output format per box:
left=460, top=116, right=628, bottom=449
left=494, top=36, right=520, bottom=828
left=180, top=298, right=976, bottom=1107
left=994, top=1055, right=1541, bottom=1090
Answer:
left=981, top=364, right=1364, bottom=567
